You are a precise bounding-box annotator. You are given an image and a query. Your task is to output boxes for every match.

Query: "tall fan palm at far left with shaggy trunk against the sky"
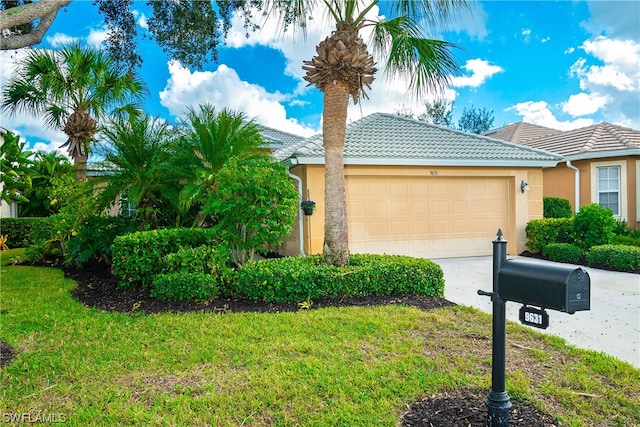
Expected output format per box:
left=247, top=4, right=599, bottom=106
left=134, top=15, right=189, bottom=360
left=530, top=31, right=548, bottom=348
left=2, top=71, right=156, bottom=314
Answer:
left=2, top=45, right=146, bottom=182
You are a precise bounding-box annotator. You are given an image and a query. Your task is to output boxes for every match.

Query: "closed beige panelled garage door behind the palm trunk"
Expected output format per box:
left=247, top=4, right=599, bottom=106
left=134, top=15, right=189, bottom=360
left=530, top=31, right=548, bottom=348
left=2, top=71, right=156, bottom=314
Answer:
left=347, top=176, right=509, bottom=258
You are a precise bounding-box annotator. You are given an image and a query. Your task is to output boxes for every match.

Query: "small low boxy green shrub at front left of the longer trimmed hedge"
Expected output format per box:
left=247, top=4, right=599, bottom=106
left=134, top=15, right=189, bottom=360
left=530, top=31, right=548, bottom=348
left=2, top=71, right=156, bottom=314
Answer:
left=151, top=272, right=219, bottom=302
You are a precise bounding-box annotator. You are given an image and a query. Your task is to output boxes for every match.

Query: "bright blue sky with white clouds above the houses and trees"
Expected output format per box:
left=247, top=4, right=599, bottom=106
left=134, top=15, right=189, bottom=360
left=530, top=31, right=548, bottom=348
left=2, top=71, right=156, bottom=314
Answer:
left=0, top=0, right=640, bottom=151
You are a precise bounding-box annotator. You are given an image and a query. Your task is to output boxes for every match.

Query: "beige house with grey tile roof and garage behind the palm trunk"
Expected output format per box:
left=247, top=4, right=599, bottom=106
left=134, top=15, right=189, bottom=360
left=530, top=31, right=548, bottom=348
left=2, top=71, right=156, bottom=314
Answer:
left=274, top=113, right=561, bottom=258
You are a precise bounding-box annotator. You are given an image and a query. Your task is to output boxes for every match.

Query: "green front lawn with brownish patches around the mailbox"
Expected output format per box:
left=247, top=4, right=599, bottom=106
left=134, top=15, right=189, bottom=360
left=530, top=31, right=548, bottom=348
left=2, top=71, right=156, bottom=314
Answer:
left=0, top=250, right=640, bottom=426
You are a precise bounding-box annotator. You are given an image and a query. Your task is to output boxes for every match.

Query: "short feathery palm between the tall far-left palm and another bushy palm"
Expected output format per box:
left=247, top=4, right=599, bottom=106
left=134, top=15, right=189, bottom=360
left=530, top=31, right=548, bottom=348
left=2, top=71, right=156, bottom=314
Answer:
left=96, top=114, right=175, bottom=229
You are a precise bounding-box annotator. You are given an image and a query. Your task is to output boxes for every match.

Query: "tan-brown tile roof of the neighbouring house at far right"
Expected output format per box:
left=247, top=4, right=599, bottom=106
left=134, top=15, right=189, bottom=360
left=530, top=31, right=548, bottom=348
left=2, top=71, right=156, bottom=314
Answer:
left=500, top=123, right=640, bottom=159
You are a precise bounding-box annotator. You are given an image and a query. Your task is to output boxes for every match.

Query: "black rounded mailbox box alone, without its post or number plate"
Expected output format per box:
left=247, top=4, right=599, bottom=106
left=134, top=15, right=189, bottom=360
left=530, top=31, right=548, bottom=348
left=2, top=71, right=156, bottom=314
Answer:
left=498, top=259, right=591, bottom=314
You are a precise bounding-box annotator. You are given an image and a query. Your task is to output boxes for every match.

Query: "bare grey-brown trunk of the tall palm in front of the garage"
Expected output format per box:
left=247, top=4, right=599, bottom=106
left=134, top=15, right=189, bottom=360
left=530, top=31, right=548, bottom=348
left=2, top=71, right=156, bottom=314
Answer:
left=322, top=81, right=349, bottom=266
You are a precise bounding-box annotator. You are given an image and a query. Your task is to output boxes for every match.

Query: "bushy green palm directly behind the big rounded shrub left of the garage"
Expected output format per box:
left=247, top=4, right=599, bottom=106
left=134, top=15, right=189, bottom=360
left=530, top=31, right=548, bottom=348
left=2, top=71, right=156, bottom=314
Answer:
left=173, top=104, right=266, bottom=226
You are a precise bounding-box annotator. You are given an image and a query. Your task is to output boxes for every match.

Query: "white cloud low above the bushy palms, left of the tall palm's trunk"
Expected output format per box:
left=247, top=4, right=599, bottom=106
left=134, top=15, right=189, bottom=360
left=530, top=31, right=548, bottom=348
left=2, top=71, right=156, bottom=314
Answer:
left=159, top=62, right=317, bottom=136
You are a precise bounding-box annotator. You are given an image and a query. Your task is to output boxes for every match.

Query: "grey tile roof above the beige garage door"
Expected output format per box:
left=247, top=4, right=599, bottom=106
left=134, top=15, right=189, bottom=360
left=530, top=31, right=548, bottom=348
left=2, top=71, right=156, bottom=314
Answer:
left=274, top=113, right=561, bottom=166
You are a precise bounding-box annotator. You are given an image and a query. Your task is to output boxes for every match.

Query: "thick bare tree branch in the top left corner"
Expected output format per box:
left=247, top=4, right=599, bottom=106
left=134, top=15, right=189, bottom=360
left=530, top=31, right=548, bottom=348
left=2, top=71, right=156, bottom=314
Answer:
left=0, top=0, right=72, bottom=50
